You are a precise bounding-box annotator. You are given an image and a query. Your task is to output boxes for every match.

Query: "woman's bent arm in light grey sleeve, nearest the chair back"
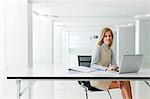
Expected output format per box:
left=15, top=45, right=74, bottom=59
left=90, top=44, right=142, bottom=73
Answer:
left=91, top=47, right=106, bottom=70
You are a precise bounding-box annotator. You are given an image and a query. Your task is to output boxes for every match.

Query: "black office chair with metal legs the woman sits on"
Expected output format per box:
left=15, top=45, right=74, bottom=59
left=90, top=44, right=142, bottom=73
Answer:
left=78, top=55, right=112, bottom=99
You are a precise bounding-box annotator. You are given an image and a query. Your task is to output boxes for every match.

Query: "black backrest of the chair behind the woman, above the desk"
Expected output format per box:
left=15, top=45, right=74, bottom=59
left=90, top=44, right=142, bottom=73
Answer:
left=78, top=55, right=91, bottom=67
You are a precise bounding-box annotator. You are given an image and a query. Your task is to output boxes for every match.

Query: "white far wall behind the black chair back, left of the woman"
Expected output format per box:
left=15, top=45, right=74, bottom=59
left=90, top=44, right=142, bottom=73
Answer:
left=68, top=32, right=98, bottom=66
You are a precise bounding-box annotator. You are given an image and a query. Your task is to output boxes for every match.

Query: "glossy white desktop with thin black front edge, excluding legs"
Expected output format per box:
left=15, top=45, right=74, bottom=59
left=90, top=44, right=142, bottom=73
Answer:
left=7, top=66, right=150, bottom=80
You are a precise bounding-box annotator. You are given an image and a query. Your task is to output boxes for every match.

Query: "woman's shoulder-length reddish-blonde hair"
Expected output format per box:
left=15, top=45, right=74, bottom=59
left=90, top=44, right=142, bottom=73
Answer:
left=96, top=27, right=113, bottom=47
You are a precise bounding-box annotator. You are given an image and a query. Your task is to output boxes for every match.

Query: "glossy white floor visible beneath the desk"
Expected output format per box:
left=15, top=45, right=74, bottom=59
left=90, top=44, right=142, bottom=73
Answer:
left=0, top=80, right=141, bottom=99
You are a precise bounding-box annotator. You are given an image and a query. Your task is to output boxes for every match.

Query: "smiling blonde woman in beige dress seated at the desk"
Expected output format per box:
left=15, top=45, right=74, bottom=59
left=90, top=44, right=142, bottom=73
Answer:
left=90, top=28, right=132, bottom=99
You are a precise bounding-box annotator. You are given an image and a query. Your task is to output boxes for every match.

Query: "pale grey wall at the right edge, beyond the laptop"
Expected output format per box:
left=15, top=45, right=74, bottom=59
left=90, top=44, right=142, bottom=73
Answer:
left=136, top=19, right=150, bottom=67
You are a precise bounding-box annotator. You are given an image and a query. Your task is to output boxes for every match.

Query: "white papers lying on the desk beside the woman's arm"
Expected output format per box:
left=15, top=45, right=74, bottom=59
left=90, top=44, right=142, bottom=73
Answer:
left=69, top=66, right=97, bottom=73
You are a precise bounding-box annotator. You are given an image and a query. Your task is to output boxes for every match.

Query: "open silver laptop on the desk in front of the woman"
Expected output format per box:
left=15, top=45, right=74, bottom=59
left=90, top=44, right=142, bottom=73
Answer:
left=111, top=54, right=143, bottom=74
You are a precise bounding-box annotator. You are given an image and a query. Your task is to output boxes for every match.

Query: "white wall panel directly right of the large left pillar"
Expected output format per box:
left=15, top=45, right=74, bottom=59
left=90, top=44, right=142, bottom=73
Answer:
left=33, top=14, right=53, bottom=65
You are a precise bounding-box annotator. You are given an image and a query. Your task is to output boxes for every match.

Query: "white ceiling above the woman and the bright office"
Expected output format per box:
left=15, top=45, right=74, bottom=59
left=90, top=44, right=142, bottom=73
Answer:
left=33, top=0, right=150, bottom=27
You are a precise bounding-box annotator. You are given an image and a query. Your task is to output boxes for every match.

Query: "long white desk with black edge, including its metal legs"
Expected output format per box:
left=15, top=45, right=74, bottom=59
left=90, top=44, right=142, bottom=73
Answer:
left=7, top=65, right=150, bottom=99
